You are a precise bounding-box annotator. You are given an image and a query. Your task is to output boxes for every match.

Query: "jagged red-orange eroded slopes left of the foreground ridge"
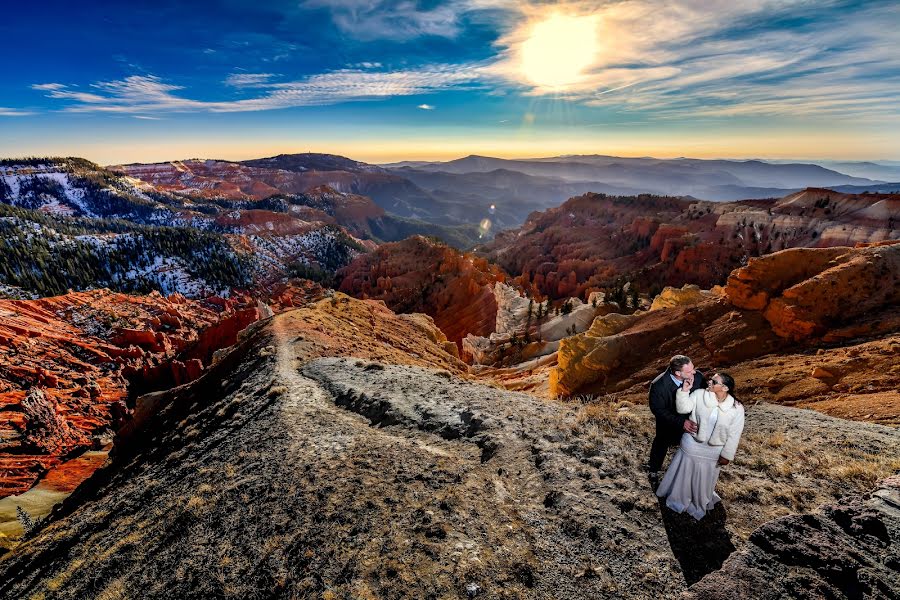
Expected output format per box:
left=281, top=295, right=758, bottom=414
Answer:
left=0, top=290, right=259, bottom=497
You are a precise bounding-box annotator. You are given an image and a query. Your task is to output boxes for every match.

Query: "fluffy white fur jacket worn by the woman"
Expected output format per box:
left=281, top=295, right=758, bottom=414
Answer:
left=675, top=388, right=744, bottom=460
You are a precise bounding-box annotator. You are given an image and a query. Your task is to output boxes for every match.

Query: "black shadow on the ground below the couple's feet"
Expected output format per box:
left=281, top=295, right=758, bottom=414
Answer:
left=659, top=498, right=735, bottom=586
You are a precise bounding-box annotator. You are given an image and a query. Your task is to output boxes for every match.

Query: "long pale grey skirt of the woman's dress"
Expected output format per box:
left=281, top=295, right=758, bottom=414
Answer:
left=656, top=410, right=722, bottom=521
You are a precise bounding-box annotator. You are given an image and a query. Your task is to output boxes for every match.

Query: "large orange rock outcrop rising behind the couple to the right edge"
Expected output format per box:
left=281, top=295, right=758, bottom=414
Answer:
left=550, top=243, right=900, bottom=397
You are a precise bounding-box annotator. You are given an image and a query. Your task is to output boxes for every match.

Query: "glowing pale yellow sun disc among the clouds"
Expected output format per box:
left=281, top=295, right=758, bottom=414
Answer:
left=521, top=15, right=597, bottom=88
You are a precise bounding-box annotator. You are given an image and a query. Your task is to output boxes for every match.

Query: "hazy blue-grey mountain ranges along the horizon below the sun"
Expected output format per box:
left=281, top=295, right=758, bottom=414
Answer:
left=383, top=155, right=900, bottom=228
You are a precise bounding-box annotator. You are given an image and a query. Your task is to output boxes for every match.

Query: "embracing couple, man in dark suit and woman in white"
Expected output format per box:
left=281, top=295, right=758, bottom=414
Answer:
left=647, top=355, right=744, bottom=521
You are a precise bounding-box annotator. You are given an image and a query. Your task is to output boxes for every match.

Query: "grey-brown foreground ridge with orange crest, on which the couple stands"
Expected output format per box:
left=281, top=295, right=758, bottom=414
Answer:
left=0, top=295, right=900, bottom=598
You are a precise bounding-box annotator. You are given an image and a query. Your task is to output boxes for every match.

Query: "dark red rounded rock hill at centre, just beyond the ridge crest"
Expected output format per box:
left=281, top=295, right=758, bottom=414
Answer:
left=339, top=236, right=504, bottom=344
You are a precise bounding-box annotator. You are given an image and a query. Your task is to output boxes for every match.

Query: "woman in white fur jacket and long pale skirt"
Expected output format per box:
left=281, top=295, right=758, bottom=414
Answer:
left=656, top=373, right=744, bottom=521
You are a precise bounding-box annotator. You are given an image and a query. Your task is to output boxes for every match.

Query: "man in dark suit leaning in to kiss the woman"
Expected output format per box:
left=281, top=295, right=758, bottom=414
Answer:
left=647, top=354, right=706, bottom=490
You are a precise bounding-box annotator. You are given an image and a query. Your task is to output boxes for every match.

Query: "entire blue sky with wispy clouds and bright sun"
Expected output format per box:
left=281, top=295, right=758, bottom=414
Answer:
left=0, top=0, right=900, bottom=164
